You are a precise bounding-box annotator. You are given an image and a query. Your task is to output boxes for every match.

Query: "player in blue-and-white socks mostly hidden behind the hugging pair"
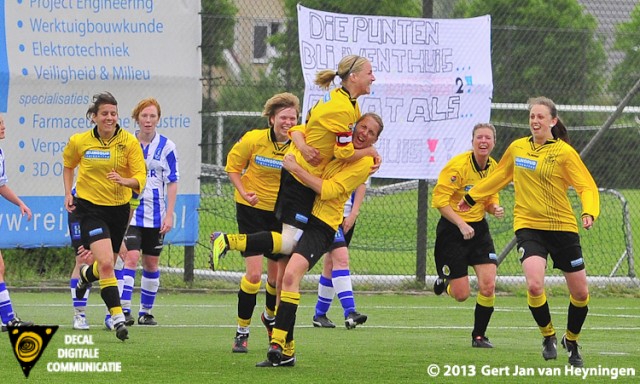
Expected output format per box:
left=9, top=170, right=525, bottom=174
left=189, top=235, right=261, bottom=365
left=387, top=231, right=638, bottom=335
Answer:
left=312, top=183, right=368, bottom=329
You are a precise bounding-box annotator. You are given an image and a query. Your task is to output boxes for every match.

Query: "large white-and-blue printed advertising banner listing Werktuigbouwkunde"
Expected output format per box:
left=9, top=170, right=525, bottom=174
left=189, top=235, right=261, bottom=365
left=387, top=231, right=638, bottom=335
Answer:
left=0, top=0, right=202, bottom=247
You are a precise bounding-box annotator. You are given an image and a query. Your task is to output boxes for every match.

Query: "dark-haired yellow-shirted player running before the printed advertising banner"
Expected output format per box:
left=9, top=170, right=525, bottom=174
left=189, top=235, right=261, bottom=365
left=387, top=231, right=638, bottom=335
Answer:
left=63, top=92, right=147, bottom=341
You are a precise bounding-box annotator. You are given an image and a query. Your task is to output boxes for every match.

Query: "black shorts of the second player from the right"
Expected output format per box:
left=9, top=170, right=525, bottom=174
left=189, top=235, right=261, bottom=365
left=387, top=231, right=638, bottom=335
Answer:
left=433, top=217, right=498, bottom=279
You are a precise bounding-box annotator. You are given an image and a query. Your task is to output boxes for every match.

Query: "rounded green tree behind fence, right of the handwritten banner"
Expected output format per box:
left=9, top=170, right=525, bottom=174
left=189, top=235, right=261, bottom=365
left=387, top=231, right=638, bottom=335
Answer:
left=454, top=0, right=606, bottom=104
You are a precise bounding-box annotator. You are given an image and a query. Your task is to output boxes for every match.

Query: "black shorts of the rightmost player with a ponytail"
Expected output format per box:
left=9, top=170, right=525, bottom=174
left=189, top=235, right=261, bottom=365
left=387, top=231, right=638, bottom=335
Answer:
left=516, top=228, right=585, bottom=272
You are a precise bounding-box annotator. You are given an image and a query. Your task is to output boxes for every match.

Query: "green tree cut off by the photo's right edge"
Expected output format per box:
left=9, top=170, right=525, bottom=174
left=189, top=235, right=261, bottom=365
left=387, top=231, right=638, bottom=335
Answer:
left=609, top=4, right=640, bottom=105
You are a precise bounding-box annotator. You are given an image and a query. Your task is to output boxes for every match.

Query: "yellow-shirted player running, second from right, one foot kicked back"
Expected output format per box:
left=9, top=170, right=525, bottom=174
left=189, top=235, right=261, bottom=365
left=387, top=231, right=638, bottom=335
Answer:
left=431, top=123, right=504, bottom=348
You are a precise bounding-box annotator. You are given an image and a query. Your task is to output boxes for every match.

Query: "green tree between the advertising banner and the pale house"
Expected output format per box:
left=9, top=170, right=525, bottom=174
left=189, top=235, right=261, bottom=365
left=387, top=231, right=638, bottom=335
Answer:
left=201, top=0, right=238, bottom=66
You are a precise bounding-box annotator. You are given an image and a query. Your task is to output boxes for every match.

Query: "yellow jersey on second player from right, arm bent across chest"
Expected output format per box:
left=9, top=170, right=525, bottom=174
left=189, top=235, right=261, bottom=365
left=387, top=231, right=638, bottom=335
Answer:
left=431, top=151, right=500, bottom=223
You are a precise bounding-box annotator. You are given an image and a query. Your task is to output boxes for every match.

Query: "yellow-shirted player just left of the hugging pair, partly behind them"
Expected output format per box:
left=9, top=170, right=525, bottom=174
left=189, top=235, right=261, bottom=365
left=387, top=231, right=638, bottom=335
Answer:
left=225, top=92, right=300, bottom=353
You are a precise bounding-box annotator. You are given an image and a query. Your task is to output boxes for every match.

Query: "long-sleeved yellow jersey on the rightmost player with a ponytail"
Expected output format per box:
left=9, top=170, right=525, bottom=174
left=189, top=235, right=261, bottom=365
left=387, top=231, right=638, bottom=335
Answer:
left=469, top=136, right=600, bottom=233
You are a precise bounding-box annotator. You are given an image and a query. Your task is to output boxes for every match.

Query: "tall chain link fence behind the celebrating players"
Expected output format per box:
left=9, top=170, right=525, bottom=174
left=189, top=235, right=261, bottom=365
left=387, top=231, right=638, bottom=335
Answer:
left=191, top=0, right=640, bottom=289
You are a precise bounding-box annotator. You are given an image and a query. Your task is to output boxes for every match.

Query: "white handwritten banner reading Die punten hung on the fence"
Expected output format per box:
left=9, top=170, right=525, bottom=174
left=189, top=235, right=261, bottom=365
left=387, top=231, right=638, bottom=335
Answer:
left=298, top=5, right=493, bottom=179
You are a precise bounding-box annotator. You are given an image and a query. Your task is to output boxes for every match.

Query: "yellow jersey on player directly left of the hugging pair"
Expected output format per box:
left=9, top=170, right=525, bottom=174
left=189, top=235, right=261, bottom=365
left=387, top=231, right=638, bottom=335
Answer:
left=224, top=128, right=290, bottom=211
